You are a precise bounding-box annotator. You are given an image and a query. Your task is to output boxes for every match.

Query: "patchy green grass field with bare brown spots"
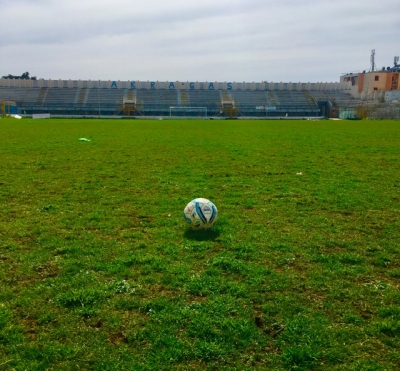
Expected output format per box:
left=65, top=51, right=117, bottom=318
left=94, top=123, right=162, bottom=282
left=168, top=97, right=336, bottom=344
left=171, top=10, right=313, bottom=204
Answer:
left=0, top=119, right=400, bottom=371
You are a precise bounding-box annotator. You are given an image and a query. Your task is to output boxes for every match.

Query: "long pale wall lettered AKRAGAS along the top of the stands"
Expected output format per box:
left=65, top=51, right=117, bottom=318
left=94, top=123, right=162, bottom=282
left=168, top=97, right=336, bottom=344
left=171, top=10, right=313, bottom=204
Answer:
left=0, top=79, right=352, bottom=91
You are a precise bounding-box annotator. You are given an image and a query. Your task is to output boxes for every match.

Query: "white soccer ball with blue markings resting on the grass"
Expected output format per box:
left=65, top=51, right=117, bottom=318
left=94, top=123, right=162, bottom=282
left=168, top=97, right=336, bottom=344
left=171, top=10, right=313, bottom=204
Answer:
left=183, top=198, right=218, bottom=230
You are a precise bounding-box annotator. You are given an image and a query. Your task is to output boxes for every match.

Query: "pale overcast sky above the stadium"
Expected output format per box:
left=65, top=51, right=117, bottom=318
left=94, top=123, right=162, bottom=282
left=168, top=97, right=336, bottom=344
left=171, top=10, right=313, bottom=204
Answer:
left=0, top=0, right=400, bottom=82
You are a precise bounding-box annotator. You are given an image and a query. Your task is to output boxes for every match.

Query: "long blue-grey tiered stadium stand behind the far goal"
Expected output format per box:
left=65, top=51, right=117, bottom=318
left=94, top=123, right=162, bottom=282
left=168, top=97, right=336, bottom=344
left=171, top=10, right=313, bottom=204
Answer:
left=0, top=80, right=360, bottom=117
